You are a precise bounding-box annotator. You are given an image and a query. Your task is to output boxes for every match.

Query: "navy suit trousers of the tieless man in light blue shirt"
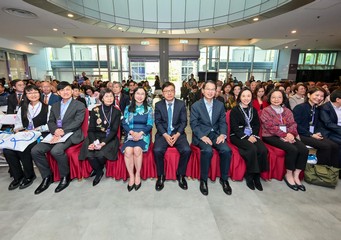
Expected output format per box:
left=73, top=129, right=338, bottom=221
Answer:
left=197, top=132, right=231, bottom=181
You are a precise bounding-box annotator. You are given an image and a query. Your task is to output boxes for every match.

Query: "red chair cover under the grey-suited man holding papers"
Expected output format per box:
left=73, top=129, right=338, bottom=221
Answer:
left=46, top=109, right=89, bottom=181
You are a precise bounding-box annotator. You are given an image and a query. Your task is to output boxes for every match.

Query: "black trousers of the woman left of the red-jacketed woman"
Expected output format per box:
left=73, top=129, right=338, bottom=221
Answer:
left=230, top=136, right=269, bottom=173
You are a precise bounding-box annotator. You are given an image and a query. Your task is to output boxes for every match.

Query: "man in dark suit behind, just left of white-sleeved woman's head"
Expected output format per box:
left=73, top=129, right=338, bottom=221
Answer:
left=7, top=79, right=25, bottom=114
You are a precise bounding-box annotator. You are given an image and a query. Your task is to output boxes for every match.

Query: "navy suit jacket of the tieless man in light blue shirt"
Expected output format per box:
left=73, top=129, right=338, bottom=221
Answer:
left=190, top=98, right=227, bottom=145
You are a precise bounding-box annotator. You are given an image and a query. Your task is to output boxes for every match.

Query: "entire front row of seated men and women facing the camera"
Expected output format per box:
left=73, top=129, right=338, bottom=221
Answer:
left=4, top=81, right=341, bottom=195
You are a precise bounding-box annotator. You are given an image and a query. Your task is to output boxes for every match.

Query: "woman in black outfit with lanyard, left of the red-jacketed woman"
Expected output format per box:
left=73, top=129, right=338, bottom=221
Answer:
left=230, top=88, right=268, bottom=191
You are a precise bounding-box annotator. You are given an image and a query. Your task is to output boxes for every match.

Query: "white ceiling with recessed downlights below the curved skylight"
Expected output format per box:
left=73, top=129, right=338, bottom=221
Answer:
left=0, top=0, right=341, bottom=50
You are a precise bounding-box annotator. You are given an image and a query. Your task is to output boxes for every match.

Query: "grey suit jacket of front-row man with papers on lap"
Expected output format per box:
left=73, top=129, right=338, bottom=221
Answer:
left=47, top=99, right=85, bottom=144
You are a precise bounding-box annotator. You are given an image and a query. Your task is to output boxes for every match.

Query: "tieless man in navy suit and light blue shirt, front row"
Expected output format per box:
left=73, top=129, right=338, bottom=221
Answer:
left=190, top=81, right=232, bottom=195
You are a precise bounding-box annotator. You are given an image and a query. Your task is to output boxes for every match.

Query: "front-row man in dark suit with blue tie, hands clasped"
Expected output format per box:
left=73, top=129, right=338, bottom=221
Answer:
left=154, top=82, right=191, bottom=191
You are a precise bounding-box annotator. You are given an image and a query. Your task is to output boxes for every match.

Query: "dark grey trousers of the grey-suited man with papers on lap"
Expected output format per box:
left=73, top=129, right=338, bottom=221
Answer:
left=31, top=138, right=72, bottom=178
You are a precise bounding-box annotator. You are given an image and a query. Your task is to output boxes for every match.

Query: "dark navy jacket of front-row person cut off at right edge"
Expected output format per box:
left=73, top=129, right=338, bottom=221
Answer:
left=320, top=102, right=341, bottom=138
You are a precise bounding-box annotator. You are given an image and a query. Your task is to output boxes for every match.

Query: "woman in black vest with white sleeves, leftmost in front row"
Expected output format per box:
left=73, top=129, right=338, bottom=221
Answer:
left=3, top=85, right=49, bottom=190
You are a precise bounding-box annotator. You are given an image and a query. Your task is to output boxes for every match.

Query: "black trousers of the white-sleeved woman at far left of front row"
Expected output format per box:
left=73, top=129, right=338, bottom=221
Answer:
left=3, top=141, right=37, bottom=180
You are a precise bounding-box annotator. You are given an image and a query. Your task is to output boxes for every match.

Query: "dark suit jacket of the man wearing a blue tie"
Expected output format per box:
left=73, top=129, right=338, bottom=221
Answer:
left=154, top=99, right=187, bottom=139
